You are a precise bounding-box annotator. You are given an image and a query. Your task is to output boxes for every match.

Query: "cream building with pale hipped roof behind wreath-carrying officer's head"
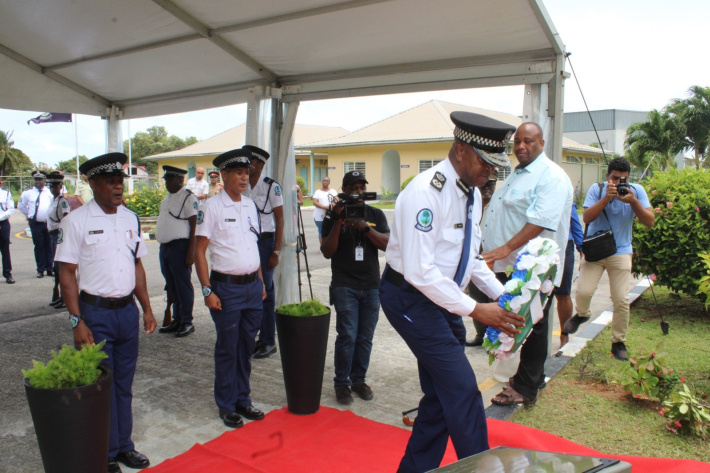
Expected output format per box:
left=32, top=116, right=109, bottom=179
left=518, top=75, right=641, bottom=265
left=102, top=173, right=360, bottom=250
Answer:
left=296, top=100, right=606, bottom=199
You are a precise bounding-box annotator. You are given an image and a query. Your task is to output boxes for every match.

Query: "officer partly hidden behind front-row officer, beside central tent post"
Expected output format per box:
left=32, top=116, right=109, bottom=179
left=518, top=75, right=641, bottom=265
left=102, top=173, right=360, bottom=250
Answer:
left=242, top=145, right=284, bottom=358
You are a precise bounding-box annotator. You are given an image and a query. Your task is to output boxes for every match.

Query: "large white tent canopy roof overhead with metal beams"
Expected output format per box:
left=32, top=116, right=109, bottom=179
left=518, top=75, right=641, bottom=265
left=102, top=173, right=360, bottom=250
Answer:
left=0, top=0, right=564, bottom=118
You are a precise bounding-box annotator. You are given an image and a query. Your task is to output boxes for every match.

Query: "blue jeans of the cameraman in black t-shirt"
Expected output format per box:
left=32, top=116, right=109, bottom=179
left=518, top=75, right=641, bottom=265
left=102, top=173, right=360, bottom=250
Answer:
left=332, top=287, right=380, bottom=387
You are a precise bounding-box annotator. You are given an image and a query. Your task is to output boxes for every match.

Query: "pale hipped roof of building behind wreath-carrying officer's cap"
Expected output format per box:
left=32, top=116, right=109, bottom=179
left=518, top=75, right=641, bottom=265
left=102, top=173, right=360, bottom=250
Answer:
left=295, top=100, right=602, bottom=154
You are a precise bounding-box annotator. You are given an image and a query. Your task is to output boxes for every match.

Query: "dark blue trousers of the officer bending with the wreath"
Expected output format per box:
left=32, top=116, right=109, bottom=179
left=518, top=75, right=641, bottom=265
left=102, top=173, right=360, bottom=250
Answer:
left=380, top=278, right=489, bottom=472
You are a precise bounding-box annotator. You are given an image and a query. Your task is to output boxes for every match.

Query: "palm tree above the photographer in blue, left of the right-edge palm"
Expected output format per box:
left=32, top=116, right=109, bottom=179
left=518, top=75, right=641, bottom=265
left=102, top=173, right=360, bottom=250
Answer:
left=624, top=110, right=686, bottom=169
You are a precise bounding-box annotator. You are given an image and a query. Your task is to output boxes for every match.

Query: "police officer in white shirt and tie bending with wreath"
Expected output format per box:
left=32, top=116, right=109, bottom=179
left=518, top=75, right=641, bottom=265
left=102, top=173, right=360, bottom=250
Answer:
left=380, top=112, right=523, bottom=472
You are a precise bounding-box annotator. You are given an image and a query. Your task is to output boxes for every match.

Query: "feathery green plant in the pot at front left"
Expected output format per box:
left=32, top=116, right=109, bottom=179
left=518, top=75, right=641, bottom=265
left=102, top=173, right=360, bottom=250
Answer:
left=22, top=340, right=108, bottom=389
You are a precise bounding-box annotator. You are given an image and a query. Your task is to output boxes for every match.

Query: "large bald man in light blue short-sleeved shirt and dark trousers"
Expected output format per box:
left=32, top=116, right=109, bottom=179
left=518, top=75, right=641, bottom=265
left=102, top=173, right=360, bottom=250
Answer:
left=481, top=123, right=573, bottom=406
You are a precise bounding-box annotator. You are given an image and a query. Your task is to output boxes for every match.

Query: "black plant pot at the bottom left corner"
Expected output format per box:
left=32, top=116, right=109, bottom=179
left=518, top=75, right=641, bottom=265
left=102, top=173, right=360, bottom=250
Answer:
left=25, top=365, right=113, bottom=473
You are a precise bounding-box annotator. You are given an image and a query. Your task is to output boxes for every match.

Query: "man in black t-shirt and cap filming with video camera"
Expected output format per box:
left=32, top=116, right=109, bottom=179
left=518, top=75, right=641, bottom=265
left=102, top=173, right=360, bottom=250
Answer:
left=321, top=171, right=390, bottom=404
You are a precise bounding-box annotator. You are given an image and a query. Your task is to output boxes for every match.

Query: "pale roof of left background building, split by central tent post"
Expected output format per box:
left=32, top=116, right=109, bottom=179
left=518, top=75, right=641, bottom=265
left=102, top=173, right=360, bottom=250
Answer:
left=144, top=123, right=348, bottom=161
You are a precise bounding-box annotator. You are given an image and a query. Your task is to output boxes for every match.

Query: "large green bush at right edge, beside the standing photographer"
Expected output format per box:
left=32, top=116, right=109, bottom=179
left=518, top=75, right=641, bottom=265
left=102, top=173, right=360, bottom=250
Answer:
left=634, top=169, right=710, bottom=297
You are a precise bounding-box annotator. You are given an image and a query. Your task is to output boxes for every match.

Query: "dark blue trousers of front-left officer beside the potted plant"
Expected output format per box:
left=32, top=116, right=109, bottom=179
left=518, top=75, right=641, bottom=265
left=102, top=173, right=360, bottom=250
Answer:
left=79, top=300, right=140, bottom=457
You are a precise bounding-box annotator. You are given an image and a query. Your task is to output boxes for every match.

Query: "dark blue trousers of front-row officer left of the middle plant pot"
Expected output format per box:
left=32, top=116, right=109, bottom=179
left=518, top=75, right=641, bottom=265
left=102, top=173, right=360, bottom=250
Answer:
left=210, top=278, right=263, bottom=413
